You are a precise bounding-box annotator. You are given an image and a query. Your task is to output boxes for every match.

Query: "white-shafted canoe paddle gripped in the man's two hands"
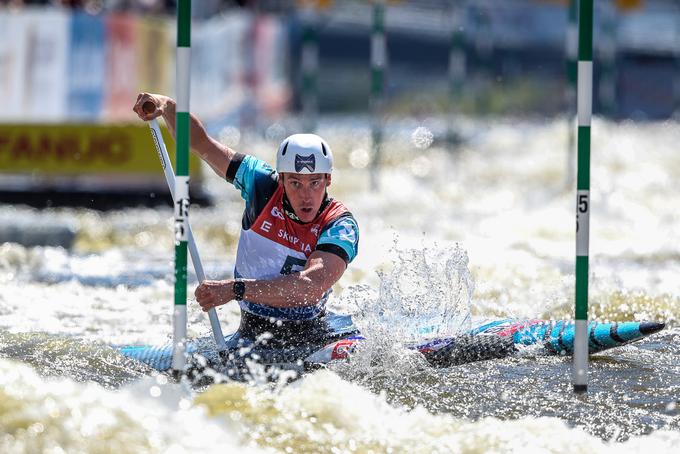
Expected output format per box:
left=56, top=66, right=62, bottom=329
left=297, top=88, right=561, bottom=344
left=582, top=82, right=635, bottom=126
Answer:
left=149, top=119, right=227, bottom=352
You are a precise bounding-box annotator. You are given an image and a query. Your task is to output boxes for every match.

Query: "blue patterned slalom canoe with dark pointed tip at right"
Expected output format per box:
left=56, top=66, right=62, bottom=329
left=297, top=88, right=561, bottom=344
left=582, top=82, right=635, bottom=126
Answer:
left=116, top=315, right=664, bottom=371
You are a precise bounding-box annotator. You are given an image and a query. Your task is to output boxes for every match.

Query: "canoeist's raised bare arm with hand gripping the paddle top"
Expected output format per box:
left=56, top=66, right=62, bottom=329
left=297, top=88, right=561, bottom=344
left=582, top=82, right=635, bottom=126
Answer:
left=132, top=93, right=236, bottom=178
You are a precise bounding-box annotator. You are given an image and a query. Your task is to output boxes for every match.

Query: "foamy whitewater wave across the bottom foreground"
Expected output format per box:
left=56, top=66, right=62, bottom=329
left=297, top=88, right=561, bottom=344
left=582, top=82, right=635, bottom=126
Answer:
left=0, top=360, right=680, bottom=453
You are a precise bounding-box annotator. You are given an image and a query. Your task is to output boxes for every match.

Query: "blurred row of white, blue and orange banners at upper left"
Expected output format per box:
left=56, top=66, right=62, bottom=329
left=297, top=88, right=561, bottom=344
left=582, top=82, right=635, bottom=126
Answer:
left=0, top=8, right=290, bottom=124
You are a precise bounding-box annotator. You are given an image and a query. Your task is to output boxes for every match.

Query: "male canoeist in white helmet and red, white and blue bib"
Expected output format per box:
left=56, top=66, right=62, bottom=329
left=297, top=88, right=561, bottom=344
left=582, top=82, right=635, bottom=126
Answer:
left=133, top=93, right=359, bottom=344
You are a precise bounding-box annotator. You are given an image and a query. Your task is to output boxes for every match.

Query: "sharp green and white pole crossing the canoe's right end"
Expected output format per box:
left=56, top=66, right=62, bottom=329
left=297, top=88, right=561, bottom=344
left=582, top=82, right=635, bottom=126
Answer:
left=573, top=0, right=593, bottom=393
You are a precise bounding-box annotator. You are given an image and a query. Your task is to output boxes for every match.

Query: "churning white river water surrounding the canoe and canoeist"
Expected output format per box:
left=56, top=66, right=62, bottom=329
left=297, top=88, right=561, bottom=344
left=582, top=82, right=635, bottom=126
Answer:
left=0, top=120, right=680, bottom=453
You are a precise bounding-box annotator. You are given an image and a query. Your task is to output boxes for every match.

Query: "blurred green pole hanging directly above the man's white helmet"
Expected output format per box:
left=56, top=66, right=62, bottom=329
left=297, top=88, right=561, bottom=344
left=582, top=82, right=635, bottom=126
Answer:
left=302, top=7, right=319, bottom=132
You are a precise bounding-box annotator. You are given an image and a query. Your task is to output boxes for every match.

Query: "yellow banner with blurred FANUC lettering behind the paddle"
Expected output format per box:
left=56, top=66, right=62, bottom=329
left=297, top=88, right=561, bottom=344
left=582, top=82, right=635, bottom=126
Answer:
left=0, top=123, right=200, bottom=180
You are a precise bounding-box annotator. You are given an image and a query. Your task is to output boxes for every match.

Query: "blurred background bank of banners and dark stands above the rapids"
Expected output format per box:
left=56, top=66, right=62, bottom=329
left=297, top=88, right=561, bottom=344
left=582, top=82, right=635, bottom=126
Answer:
left=0, top=0, right=680, bottom=207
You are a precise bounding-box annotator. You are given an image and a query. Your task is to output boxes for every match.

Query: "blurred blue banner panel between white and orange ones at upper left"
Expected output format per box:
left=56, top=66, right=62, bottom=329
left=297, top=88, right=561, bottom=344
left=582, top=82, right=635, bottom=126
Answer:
left=68, top=12, right=106, bottom=121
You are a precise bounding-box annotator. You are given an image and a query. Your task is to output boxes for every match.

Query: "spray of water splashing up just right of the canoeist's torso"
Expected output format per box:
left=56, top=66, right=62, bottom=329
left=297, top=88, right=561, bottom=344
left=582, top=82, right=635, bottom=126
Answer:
left=334, top=244, right=474, bottom=380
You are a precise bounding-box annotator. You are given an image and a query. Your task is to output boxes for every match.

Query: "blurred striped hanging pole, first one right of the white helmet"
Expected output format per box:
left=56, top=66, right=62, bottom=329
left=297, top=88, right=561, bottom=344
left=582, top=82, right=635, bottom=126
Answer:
left=370, top=0, right=387, bottom=190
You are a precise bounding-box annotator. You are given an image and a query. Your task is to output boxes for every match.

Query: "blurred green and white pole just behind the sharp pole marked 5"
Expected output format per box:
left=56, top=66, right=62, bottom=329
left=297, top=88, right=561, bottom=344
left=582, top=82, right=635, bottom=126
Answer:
left=566, top=0, right=578, bottom=188
